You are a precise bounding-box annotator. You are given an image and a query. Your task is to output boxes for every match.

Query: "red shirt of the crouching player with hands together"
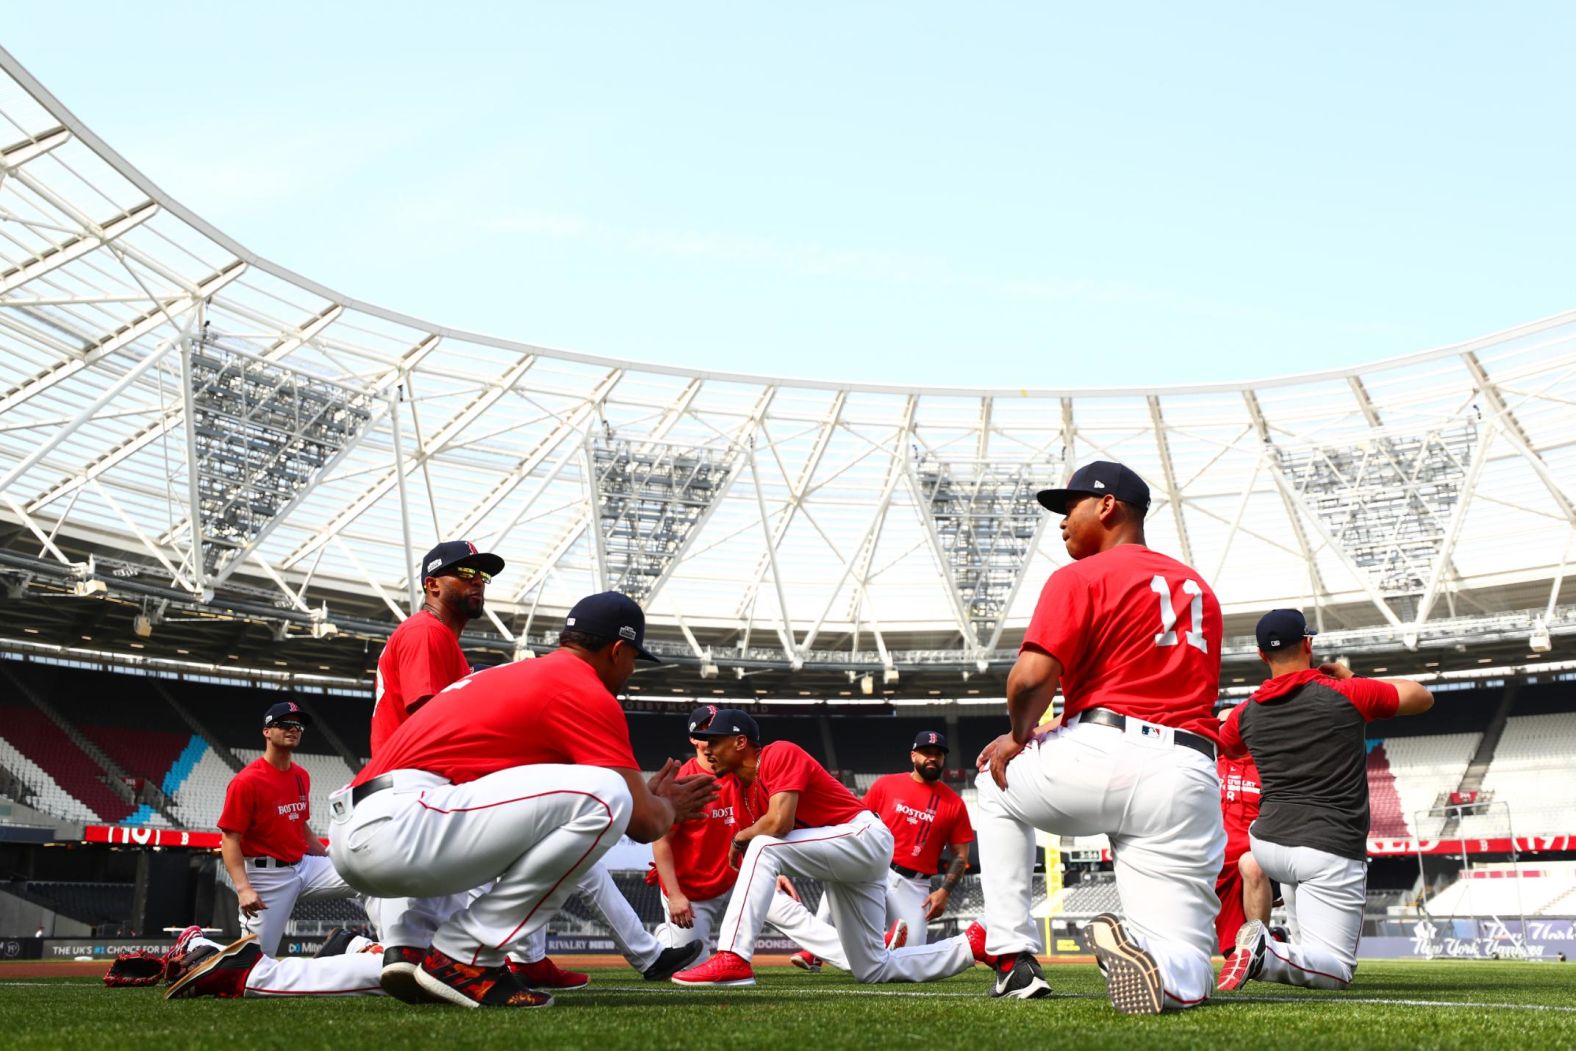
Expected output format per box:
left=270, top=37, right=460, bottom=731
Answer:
left=351, top=649, right=640, bottom=785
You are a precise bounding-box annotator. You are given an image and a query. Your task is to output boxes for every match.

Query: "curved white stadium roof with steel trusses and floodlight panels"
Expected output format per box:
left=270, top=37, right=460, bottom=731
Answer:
left=0, top=50, right=1576, bottom=693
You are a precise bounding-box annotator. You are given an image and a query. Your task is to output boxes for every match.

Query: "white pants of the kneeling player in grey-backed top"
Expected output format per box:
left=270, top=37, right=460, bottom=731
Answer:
left=1248, top=830, right=1368, bottom=990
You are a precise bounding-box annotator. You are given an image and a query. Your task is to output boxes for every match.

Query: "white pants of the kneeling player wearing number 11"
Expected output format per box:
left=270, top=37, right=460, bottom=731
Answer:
left=974, top=719, right=1226, bottom=1008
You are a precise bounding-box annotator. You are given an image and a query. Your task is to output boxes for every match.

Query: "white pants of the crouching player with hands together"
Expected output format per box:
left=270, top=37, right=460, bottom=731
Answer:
left=329, top=764, right=632, bottom=966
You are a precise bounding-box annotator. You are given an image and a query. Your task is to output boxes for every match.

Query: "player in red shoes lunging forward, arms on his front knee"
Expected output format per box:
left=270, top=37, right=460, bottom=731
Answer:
left=673, top=707, right=983, bottom=985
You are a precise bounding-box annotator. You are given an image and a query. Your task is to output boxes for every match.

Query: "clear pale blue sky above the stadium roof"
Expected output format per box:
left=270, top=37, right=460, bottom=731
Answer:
left=3, top=0, right=1576, bottom=386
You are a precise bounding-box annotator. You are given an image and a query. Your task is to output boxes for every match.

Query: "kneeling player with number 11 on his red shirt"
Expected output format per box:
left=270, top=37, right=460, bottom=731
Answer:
left=976, top=460, right=1226, bottom=1013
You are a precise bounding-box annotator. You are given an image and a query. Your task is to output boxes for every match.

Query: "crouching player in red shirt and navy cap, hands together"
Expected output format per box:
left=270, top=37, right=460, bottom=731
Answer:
left=331, top=591, right=717, bottom=1008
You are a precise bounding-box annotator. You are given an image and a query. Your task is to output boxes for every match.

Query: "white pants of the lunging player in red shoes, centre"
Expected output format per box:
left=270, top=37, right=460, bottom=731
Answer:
left=717, top=810, right=970, bottom=982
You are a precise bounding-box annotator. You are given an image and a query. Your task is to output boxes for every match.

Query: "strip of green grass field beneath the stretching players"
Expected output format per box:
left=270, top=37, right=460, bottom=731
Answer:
left=0, top=961, right=1576, bottom=1051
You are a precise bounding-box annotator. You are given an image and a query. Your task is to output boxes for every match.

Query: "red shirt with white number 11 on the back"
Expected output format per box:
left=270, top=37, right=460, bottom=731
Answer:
left=1023, top=544, right=1223, bottom=741
